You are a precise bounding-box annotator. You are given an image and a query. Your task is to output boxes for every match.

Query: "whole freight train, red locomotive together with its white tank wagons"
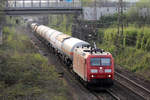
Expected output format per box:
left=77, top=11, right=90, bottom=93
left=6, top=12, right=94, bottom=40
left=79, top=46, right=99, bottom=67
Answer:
left=30, top=23, right=114, bottom=87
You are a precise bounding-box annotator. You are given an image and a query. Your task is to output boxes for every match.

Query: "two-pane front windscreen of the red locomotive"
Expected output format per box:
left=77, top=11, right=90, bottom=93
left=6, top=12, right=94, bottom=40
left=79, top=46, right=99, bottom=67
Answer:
left=90, top=58, right=111, bottom=66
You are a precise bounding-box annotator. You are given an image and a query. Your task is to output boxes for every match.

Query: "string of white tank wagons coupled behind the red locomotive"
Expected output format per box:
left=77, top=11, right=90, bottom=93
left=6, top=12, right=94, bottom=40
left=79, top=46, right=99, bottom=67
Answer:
left=31, top=23, right=89, bottom=64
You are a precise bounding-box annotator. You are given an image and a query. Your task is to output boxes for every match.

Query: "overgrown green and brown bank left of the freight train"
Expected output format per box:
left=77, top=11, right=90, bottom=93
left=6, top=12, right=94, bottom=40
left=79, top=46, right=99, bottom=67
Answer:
left=0, top=19, right=71, bottom=100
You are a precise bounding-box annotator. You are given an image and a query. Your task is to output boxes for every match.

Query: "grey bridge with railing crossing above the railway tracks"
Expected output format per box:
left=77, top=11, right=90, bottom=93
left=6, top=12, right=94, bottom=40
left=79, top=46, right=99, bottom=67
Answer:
left=4, top=0, right=82, bottom=15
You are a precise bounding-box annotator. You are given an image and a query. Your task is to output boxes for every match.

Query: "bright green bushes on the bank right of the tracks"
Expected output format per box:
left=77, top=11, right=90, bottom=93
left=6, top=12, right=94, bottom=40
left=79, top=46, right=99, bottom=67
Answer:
left=98, top=26, right=150, bottom=80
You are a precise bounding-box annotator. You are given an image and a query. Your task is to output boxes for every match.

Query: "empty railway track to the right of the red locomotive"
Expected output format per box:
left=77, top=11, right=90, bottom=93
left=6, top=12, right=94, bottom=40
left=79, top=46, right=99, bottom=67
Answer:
left=115, top=72, right=150, bottom=100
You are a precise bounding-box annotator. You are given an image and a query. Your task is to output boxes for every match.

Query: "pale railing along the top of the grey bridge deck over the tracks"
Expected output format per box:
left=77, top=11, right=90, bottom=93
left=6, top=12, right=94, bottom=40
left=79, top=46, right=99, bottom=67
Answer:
left=6, top=0, right=82, bottom=9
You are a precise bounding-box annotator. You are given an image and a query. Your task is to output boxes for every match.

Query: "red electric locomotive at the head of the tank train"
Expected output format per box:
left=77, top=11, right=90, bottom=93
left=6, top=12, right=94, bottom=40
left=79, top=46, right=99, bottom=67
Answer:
left=73, top=47, right=114, bottom=87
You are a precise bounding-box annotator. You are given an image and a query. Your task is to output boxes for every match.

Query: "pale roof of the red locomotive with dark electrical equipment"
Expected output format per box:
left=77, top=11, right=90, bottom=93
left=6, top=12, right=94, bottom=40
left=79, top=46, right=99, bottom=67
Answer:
left=75, top=47, right=111, bottom=58
